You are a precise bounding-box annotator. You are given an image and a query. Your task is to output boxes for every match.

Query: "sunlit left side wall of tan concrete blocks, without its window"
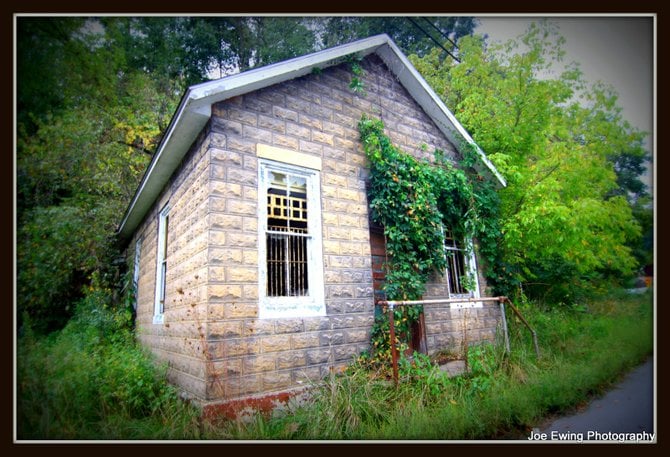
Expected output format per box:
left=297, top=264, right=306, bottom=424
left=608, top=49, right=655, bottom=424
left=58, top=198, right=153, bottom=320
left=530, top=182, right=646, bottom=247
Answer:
left=129, top=127, right=210, bottom=399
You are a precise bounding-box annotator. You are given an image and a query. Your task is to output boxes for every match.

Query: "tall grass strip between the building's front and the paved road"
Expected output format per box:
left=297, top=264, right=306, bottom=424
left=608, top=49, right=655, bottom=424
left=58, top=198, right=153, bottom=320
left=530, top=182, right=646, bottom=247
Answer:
left=208, top=286, right=653, bottom=440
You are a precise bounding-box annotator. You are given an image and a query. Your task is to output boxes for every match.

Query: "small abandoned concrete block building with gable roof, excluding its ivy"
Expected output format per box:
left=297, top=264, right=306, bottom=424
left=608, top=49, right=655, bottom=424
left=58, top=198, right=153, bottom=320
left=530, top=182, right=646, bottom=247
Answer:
left=118, top=35, right=504, bottom=414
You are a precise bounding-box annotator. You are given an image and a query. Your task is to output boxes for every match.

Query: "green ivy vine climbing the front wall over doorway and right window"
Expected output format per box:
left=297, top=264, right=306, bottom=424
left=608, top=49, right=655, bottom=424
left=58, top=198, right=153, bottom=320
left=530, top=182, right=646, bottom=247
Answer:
left=358, top=114, right=500, bottom=362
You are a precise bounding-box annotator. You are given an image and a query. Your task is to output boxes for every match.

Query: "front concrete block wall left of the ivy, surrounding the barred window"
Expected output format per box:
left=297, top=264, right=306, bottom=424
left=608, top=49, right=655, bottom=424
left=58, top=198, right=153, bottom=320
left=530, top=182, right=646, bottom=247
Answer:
left=208, top=62, right=373, bottom=400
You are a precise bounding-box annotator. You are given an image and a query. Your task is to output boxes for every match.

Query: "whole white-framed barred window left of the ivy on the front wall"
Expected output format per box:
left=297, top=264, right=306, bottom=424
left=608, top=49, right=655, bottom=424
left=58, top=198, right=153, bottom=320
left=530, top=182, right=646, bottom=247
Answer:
left=259, top=161, right=325, bottom=317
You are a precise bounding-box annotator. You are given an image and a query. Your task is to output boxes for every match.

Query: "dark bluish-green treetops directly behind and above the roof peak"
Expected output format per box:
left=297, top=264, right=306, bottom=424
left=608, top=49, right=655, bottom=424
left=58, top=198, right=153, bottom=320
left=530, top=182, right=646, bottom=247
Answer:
left=181, top=16, right=476, bottom=77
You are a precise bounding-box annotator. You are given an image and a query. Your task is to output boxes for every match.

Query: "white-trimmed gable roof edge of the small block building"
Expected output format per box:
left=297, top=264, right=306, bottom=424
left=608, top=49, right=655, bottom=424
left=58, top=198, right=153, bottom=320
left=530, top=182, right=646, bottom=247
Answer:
left=117, top=34, right=507, bottom=240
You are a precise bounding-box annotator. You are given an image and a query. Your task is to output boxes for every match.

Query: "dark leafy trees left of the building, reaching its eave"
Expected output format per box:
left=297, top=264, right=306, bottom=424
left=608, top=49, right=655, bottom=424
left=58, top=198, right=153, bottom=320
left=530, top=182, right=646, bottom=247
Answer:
left=16, top=18, right=177, bottom=332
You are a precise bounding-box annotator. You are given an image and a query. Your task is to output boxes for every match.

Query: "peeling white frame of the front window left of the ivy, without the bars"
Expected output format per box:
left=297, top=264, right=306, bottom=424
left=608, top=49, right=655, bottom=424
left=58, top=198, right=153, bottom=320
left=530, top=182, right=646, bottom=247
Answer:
left=258, top=159, right=326, bottom=319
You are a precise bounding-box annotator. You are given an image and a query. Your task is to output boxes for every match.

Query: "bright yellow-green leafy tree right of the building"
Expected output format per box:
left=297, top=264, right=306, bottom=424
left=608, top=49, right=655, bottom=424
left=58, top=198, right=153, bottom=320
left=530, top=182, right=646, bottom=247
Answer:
left=412, top=23, right=645, bottom=302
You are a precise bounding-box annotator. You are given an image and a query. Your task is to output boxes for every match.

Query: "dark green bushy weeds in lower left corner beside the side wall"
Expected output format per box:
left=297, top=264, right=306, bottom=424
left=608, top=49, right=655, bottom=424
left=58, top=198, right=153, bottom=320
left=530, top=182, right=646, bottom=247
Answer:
left=16, top=280, right=199, bottom=440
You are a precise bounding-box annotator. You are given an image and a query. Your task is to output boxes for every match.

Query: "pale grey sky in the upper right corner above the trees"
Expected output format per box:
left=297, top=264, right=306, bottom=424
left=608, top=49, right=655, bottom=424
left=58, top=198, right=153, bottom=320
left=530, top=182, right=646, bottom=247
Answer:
left=475, top=15, right=655, bottom=191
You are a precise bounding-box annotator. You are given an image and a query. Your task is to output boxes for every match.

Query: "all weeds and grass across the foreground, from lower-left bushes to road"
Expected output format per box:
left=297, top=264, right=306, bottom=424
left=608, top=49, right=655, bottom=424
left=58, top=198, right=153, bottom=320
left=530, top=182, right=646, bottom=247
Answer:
left=17, top=286, right=653, bottom=440
